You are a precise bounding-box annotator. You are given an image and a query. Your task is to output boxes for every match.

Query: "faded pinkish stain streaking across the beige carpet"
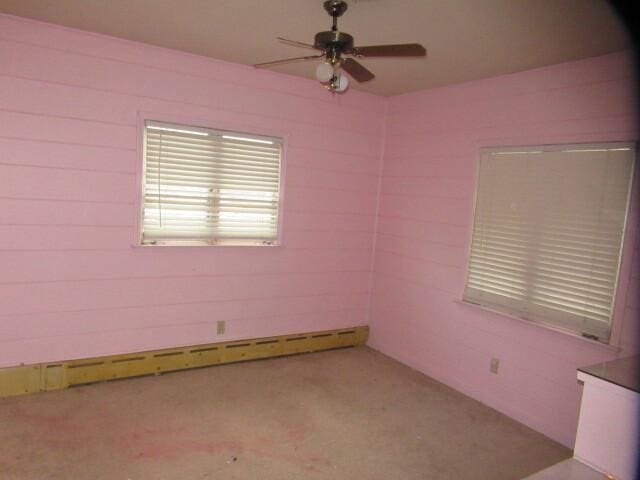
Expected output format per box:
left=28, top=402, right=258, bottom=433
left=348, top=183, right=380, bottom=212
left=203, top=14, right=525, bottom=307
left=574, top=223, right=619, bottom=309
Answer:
left=0, top=403, right=330, bottom=473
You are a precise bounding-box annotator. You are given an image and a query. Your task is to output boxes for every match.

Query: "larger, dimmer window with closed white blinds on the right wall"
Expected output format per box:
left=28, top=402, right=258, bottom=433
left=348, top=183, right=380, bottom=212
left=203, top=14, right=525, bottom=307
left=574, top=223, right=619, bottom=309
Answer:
left=464, top=143, right=635, bottom=342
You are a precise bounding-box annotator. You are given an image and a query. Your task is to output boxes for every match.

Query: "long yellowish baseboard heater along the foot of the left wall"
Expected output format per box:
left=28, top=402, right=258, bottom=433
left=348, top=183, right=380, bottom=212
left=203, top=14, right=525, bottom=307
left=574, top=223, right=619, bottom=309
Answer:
left=0, top=326, right=369, bottom=397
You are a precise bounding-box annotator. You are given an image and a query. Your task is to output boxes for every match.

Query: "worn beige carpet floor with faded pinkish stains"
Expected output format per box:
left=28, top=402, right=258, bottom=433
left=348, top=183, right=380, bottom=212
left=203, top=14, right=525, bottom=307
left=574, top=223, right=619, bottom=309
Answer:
left=0, top=347, right=571, bottom=480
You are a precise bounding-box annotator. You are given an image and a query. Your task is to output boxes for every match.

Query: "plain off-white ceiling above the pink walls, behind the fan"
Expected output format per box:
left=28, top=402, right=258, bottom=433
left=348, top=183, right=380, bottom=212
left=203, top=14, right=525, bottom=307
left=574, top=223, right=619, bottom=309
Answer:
left=0, top=0, right=631, bottom=95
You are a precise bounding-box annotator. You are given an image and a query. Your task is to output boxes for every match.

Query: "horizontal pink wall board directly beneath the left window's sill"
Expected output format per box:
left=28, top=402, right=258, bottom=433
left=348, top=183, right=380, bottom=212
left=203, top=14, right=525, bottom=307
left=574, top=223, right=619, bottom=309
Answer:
left=0, top=246, right=370, bottom=287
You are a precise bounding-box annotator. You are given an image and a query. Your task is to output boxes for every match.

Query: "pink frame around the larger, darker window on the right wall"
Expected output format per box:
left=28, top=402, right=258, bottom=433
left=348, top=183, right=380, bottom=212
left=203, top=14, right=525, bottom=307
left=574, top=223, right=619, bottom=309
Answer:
left=456, top=140, right=640, bottom=344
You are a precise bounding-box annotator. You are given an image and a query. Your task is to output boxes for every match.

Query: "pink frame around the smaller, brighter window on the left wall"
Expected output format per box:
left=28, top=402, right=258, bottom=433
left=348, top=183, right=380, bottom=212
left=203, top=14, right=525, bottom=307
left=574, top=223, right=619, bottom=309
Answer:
left=136, top=115, right=290, bottom=251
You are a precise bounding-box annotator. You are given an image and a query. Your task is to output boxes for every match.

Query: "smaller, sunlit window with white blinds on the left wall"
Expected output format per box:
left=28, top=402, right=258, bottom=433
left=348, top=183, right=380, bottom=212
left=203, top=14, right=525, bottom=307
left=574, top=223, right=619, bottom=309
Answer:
left=141, top=120, right=282, bottom=245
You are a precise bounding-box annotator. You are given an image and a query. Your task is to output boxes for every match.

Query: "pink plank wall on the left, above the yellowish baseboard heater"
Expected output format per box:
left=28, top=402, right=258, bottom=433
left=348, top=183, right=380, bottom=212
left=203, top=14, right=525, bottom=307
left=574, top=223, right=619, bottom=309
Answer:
left=0, top=16, right=385, bottom=366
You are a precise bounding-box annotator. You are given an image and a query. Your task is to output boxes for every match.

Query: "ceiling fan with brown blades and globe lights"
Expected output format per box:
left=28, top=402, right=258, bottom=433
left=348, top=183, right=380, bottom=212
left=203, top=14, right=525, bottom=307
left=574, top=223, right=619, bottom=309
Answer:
left=254, top=0, right=427, bottom=92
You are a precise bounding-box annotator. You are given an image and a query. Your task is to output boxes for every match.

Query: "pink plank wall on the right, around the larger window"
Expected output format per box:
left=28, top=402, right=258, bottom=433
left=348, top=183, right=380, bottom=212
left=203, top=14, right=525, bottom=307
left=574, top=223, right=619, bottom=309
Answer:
left=370, top=50, right=640, bottom=446
